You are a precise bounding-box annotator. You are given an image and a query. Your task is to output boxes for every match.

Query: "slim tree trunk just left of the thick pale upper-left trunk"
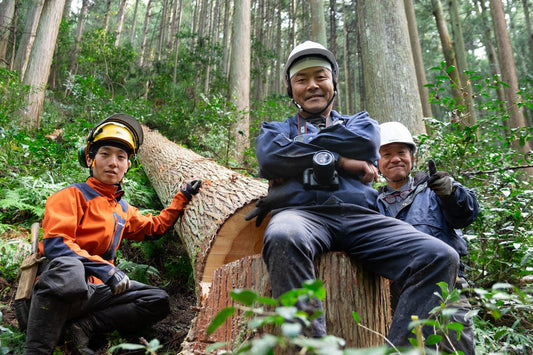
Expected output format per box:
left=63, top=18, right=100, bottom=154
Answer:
left=13, top=0, right=44, bottom=78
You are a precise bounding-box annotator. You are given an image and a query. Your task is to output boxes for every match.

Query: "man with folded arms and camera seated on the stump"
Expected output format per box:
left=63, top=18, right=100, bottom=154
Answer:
left=246, top=41, right=459, bottom=346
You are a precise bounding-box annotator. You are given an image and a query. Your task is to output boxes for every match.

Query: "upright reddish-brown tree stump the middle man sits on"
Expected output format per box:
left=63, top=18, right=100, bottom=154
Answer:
left=180, top=252, right=391, bottom=355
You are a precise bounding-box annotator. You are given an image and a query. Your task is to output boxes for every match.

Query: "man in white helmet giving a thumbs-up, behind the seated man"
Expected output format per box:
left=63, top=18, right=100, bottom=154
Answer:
left=377, top=122, right=479, bottom=354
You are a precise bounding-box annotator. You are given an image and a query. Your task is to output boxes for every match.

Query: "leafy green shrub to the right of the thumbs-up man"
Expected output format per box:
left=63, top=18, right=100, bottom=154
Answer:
left=418, top=67, right=533, bottom=353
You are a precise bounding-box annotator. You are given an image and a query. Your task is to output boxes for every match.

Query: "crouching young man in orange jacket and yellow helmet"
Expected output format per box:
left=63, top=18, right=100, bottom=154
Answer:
left=26, top=113, right=201, bottom=355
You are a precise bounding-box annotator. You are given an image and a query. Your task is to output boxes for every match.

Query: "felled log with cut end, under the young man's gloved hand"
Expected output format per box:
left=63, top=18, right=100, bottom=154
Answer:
left=139, top=127, right=267, bottom=289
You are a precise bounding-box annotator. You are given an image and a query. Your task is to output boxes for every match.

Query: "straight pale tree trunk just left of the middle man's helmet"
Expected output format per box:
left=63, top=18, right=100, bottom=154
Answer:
left=225, top=0, right=251, bottom=164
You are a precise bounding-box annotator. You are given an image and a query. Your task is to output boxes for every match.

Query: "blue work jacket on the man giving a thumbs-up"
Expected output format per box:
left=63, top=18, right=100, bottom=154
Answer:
left=377, top=172, right=479, bottom=256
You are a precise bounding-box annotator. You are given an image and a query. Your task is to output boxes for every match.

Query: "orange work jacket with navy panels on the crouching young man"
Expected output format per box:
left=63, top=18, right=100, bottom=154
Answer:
left=39, top=177, right=189, bottom=283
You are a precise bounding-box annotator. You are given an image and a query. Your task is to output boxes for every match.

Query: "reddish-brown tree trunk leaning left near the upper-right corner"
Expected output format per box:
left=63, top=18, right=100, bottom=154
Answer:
left=489, top=0, right=533, bottom=157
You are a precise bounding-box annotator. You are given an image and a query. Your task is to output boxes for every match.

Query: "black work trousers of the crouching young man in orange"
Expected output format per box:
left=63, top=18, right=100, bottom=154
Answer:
left=26, top=257, right=170, bottom=354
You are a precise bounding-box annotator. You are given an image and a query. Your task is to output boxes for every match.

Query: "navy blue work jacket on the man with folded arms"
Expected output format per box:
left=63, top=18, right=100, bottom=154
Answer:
left=256, top=111, right=380, bottom=210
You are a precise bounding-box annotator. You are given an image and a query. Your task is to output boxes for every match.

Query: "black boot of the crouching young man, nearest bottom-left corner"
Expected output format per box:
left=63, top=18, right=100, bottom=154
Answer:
left=26, top=294, right=68, bottom=355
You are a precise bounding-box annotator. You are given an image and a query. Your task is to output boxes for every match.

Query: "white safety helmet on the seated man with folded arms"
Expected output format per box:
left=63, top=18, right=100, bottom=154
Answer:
left=283, top=41, right=339, bottom=98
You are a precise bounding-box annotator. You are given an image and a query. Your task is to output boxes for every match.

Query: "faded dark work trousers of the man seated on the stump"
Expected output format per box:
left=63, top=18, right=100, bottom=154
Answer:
left=262, top=204, right=459, bottom=346
